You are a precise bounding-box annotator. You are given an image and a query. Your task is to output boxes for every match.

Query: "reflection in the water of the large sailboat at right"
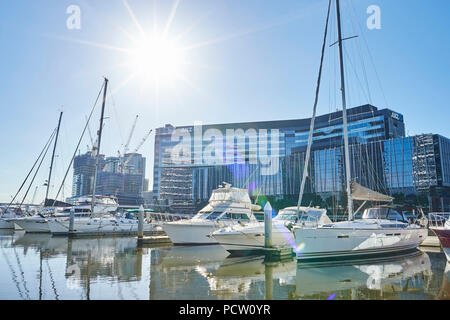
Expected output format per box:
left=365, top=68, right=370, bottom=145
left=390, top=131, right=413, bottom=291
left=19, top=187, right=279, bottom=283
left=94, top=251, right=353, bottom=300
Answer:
left=296, top=252, right=432, bottom=300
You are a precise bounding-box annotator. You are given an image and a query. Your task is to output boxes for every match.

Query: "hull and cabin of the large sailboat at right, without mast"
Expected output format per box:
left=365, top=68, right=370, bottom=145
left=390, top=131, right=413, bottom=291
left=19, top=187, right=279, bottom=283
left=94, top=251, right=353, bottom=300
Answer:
left=294, top=206, right=428, bottom=262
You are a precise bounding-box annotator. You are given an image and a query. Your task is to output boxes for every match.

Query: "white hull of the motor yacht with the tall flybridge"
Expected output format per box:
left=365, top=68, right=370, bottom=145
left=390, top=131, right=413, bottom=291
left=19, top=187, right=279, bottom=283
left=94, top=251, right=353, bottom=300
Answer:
left=163, top=222, right=218, bottom=245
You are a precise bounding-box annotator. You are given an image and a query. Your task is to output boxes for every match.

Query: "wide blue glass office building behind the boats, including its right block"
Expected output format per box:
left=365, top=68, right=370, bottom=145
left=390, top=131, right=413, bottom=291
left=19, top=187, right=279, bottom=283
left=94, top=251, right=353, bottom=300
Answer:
left=153, top=105, right=436, bottom=210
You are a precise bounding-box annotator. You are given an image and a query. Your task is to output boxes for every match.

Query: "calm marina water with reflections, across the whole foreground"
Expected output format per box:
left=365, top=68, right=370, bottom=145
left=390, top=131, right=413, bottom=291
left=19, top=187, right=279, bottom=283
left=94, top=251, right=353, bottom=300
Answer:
left=0, top=231, right=450, bottom=300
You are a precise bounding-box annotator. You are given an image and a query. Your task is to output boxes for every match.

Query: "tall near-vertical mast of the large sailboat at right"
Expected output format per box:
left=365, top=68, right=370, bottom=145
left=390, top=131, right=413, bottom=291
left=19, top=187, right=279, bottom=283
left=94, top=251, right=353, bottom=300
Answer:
left=336, top=0, right=353, bottom=221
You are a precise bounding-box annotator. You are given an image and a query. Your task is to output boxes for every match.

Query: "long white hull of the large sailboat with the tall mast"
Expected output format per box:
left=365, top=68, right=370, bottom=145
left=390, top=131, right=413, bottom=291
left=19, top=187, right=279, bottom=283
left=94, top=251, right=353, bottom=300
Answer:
left=294, top=228, right=427, bottom=262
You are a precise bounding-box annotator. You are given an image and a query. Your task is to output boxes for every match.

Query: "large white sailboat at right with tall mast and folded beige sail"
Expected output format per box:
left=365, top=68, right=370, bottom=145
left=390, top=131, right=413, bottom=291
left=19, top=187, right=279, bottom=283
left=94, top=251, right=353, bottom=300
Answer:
left=294, top=0, right=428, bottom=262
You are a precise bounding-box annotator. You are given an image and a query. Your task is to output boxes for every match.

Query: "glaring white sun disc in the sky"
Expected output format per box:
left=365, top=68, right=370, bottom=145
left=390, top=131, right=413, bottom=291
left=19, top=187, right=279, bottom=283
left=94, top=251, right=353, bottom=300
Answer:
left=127, top=34, right=186, bottom=83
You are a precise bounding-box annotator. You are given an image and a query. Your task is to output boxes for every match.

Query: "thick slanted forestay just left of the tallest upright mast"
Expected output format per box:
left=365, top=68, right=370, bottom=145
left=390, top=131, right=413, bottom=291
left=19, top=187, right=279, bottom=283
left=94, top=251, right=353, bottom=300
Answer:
left=297, top=0, right=331, bottom=211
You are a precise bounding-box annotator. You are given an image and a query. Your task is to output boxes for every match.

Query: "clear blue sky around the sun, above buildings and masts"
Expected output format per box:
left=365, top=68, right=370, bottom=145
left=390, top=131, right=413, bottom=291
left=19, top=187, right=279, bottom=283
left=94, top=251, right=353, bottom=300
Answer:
left=0, top=0, right=450, bottom=201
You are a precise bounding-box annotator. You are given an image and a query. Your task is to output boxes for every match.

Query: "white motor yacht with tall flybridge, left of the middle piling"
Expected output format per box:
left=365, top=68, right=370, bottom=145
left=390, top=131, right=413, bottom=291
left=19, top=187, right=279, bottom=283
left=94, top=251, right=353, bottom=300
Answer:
left=163, top=184, right=261, bottom=245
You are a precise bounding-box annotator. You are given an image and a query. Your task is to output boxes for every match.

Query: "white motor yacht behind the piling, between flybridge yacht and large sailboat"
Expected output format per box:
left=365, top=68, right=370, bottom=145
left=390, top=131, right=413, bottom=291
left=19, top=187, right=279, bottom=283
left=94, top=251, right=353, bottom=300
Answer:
left=212, top=207, right=331, bottom=255
